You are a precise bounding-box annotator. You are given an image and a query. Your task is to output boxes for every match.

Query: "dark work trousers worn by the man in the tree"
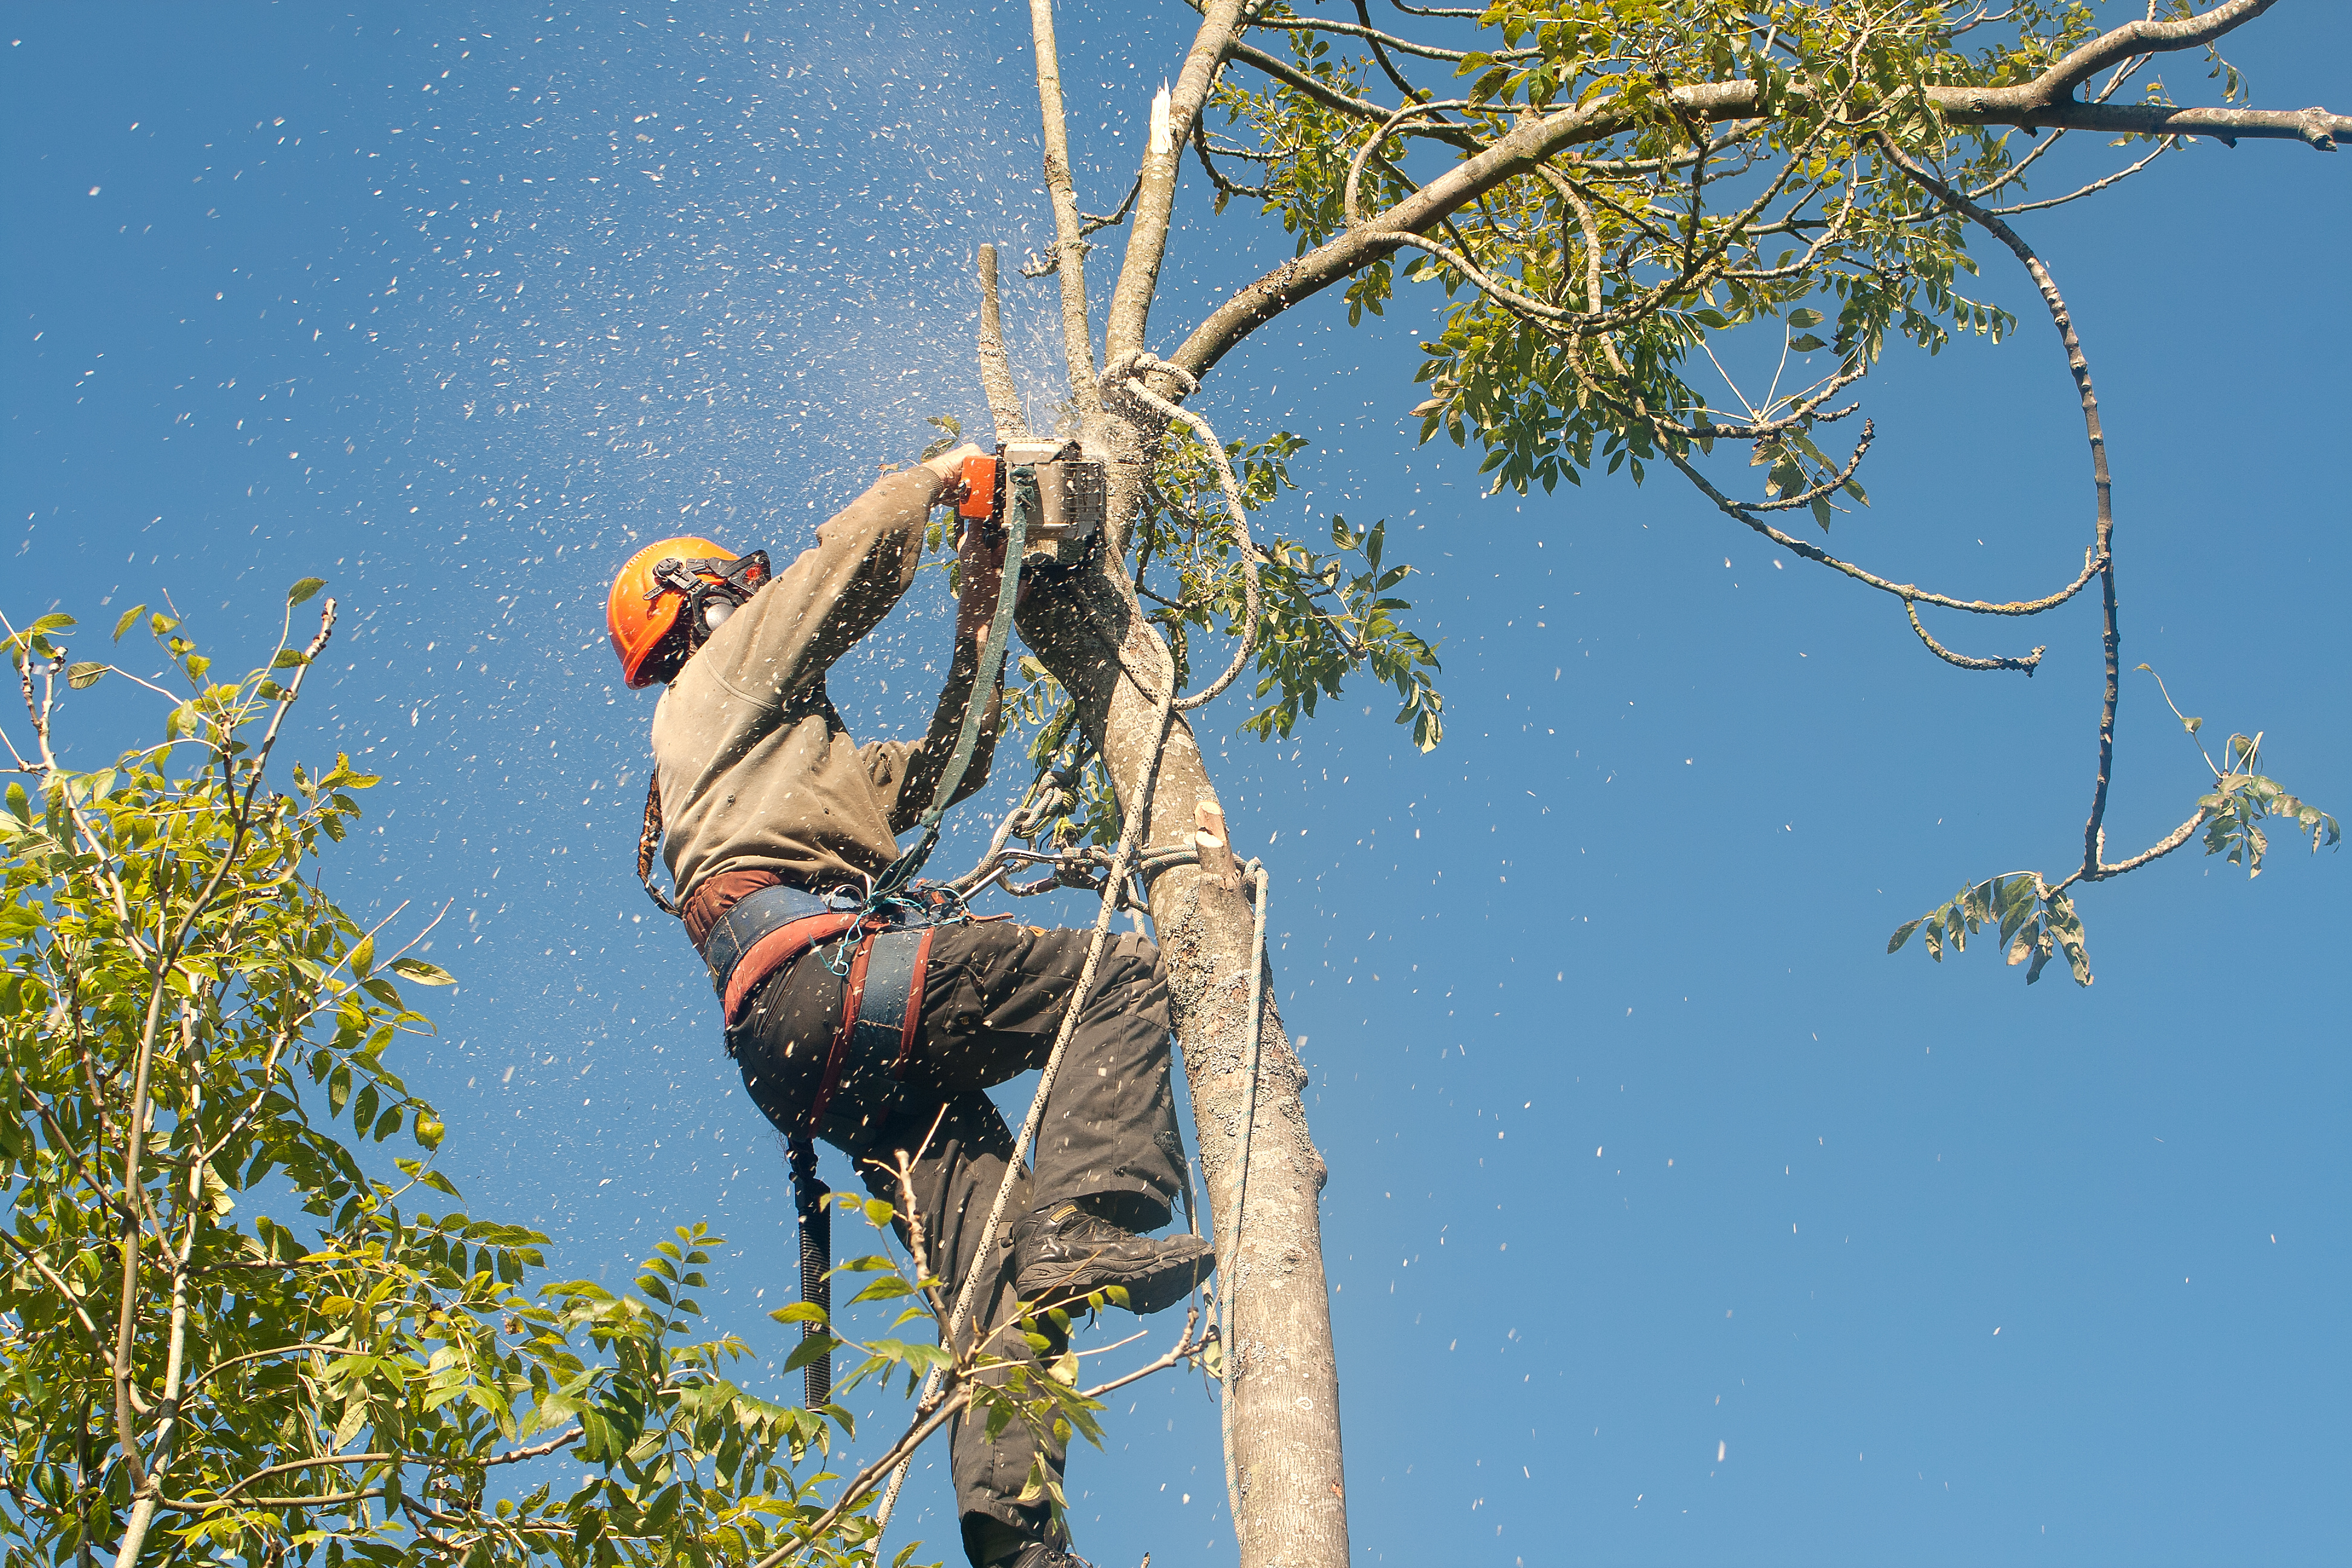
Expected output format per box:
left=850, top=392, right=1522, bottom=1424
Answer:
left=727, top=921, right=1183, bottom=1544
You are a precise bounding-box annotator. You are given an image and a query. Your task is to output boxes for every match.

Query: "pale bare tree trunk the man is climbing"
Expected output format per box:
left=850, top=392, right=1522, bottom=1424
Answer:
left=1021, top=419, right=1348, bottom=1568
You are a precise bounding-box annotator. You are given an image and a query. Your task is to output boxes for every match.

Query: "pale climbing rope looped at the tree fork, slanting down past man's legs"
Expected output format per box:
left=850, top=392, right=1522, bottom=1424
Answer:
left=875, top=353, right=1266, bottom=1532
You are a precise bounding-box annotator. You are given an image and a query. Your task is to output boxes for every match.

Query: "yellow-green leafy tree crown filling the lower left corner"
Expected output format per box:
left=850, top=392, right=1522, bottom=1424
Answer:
left=0, top=601, right=1096, bottom=1568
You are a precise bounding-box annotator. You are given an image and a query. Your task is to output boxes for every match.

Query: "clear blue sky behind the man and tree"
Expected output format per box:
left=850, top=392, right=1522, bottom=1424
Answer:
left=0, top=5, right=2352, bottom=1566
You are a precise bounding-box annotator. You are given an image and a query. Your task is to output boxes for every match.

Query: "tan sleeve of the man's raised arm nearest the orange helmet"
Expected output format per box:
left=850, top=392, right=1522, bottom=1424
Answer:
left=689, top=468, right=938, bottom=701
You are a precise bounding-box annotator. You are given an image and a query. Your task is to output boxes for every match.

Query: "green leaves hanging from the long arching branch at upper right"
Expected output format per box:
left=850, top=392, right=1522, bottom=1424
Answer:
left=1192, top=0, right=2336, bottom=985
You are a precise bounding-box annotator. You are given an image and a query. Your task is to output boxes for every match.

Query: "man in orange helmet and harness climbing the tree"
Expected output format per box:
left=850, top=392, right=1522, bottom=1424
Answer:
left=607, top=446, right=1209, bottom=1568
